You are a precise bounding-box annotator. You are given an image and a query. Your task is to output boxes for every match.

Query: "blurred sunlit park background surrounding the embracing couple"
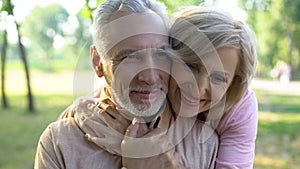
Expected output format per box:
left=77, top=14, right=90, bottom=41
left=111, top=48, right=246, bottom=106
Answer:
left=0, top=0, right=300, bottom=169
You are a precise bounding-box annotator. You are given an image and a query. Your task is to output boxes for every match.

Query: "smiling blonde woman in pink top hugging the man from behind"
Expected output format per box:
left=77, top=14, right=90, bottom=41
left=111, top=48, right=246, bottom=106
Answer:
left=168, top=7, right=258, bottom=169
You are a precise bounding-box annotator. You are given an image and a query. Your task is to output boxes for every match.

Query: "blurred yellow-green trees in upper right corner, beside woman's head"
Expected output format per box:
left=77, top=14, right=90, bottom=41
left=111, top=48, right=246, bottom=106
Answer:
left=239, top=0, right=300, bottom=79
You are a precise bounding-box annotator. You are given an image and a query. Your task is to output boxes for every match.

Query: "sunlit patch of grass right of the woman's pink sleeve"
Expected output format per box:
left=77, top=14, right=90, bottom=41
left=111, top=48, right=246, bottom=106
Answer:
left=255, top=90, right=300, bottom=169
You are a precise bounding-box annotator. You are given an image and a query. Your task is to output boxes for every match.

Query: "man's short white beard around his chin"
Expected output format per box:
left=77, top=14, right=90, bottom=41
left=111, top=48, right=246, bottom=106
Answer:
left=111, top=86, right=167, bottom=117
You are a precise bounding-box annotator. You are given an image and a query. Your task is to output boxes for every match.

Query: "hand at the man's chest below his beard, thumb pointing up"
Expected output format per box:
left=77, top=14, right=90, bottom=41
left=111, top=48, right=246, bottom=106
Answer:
left=121, top=118, right=185, bottom=169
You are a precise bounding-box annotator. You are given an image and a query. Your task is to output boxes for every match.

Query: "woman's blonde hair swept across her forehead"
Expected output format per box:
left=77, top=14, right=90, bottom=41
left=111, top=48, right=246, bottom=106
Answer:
left=170, top=7, right=257, bottom=112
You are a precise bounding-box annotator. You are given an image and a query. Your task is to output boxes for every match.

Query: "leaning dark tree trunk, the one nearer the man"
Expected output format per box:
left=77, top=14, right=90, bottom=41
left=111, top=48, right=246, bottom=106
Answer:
left=16, top=23, right=34, bottom=112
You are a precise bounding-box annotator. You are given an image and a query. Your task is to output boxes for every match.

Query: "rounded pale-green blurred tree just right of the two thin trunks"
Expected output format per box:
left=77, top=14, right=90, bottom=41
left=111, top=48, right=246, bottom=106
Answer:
left=22, top=4, right=70, bottom=71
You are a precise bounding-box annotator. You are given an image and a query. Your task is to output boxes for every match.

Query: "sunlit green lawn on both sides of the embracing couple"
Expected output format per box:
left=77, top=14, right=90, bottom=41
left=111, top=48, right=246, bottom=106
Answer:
left=0, top=72, right=300, bottom=169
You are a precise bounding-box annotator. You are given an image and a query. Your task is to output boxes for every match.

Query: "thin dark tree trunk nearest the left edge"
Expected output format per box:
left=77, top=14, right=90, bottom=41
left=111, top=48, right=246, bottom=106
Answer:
left=1, top=30, right=9, bottom=108
